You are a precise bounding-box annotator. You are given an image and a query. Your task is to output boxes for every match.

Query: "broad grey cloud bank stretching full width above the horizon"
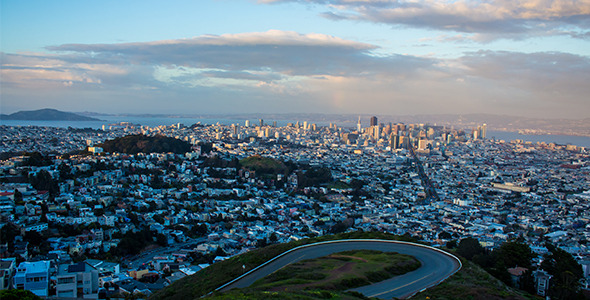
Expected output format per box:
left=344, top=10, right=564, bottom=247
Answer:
left=0, top=30, right=590, bottom=117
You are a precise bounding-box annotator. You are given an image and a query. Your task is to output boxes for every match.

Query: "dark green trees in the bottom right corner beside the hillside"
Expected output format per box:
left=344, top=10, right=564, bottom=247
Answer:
left=454, top=238, right=584, bottom=299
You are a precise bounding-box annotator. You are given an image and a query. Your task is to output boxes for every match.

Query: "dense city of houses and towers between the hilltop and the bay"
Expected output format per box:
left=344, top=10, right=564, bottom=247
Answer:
left=0, top=118, right=590, bottom=298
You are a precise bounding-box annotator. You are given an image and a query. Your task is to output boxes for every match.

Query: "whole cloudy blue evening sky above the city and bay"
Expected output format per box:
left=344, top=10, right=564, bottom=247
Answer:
left=0, top=0, right=590, bottom=118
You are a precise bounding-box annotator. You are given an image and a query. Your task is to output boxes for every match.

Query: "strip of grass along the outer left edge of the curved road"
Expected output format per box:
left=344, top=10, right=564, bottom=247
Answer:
left=150, top=232, right=415, bottom=300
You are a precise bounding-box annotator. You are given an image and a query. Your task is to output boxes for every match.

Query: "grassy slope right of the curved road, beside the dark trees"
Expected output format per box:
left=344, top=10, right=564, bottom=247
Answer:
left=412, top=259, right=537, bottom=300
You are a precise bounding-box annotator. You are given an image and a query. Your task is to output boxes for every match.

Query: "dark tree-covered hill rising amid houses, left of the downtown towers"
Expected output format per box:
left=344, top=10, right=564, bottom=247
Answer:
left=99, top=134, right=191, bottom=154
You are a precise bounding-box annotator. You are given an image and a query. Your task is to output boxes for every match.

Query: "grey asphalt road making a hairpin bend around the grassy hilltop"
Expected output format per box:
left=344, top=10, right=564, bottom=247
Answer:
left=217, top=240, right=461, bottom=299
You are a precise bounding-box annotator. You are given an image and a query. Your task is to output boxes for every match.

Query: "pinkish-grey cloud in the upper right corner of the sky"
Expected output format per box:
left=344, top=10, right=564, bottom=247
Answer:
left=260, top=0, right=590, bottom=41
